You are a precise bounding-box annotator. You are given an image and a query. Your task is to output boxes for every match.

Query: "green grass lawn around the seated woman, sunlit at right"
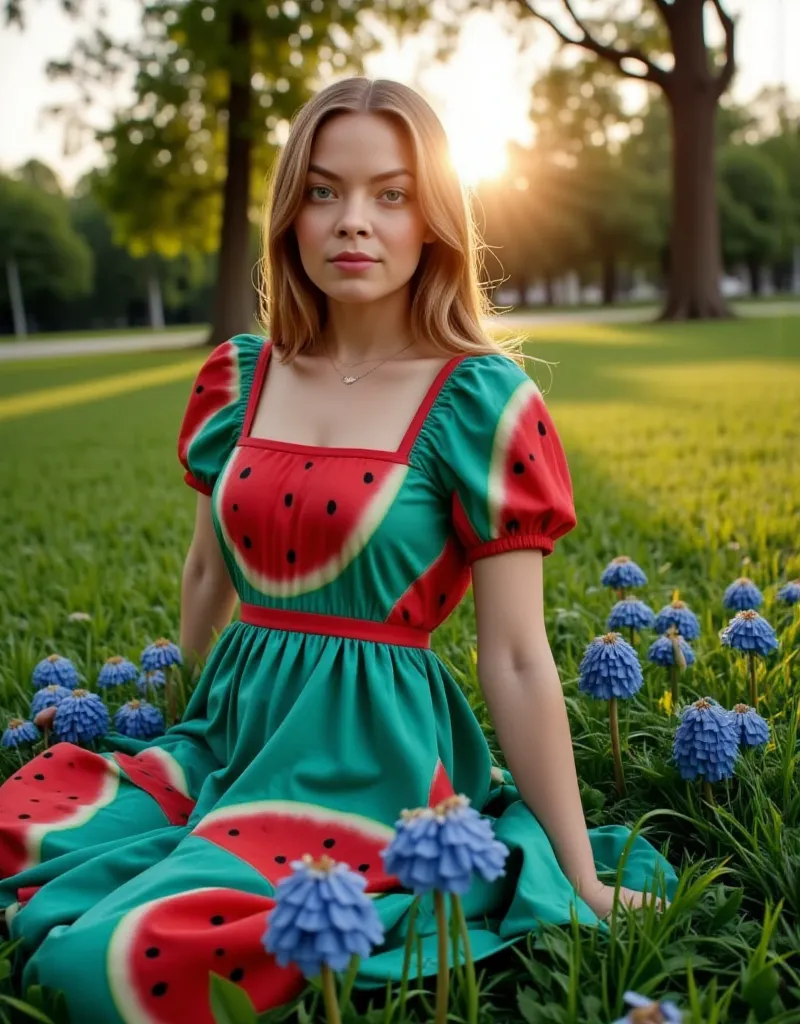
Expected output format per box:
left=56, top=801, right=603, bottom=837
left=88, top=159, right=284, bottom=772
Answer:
left=0, top=317, right=800, bottom=1024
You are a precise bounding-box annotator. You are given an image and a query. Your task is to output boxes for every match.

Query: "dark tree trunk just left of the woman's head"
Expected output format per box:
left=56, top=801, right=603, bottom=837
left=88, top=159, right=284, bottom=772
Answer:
left=208, top=12, right=253, bottom=345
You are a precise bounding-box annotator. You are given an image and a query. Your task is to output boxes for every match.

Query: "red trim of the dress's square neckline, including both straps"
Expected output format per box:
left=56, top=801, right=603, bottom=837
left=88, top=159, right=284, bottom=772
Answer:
left=238, top=339, right=468, bottom=462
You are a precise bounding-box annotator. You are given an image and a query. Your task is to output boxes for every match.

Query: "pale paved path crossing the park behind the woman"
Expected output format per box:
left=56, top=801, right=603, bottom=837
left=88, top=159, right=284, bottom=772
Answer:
left=0, top=302, right=800, bottom=362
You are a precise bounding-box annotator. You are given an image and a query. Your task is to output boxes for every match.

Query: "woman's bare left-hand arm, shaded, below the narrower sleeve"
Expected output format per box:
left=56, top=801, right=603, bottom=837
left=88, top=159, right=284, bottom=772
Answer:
left=180, top=494, right=237, bottom=666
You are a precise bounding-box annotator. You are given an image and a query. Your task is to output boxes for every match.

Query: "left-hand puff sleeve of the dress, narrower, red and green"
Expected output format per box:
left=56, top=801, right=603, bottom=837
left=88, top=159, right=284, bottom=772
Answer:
left=178, top=334, right=264, bottom=495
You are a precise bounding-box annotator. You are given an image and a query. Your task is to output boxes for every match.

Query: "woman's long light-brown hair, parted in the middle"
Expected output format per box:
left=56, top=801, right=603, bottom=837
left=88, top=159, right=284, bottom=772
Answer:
left=253, top=76, right=533, bottom=366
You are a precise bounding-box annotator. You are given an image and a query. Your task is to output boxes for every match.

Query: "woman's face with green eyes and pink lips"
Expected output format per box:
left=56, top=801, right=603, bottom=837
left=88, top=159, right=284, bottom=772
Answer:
left=294, top=114, right=435, bottom=303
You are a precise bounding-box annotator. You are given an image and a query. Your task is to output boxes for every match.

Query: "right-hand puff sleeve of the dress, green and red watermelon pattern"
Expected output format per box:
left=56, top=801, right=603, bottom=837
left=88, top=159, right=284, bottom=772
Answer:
left=440, top=354, right=577, bottom=564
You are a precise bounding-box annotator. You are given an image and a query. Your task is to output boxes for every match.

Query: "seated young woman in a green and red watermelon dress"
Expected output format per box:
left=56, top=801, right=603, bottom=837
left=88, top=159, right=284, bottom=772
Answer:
left=0, top=78, right=675, bottom=1024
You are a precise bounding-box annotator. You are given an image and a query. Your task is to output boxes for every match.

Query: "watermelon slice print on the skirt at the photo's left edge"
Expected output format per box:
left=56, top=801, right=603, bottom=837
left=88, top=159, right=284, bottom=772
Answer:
left=0, top=743, right=120, bottom=878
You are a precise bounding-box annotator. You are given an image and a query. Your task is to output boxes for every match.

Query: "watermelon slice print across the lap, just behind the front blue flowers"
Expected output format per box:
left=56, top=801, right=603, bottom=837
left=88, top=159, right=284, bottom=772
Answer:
left=192, top=760, right=454, bottom=893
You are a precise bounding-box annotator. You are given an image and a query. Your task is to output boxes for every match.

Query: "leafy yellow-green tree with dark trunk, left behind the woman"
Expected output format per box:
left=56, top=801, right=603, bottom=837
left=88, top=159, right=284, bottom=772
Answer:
left=28, top=0, right=452, bottom=342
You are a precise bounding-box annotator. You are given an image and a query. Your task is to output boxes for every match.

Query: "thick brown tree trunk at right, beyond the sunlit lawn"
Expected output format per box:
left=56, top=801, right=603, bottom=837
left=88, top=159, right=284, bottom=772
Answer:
left=661, top=0, right=732, bottom=321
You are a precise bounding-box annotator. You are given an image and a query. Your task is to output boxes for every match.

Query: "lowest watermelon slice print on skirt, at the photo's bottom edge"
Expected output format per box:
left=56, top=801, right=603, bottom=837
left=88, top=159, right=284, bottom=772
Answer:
left=106, top=888, right=305, bottom=1024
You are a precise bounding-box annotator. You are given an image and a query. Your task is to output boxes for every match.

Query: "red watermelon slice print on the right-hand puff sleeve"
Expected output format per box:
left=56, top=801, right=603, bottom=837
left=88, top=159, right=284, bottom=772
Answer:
left=489, top=378, right=572, bottom=540
